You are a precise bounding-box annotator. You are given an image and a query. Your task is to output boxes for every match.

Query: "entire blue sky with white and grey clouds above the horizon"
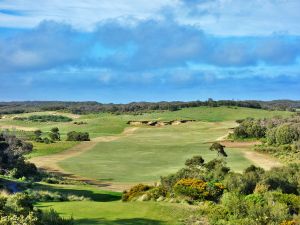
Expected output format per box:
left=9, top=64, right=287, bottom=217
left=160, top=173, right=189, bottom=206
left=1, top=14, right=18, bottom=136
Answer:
left=0, top=0, right=300, bottom=103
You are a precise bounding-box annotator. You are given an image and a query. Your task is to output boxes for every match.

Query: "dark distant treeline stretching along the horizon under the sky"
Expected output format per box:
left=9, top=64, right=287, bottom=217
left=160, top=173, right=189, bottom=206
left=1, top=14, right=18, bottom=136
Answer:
left=0, top=99, right=300, bottom=114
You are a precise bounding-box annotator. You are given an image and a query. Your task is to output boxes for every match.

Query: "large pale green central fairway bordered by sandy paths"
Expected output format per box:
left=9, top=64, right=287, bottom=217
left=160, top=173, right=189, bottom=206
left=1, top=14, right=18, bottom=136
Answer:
left=59, top=122, right=254, bottom=183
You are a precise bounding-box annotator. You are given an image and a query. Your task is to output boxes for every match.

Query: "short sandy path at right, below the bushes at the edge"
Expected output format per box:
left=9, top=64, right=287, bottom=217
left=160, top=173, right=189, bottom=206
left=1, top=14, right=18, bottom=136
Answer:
left=221, top=141, right=282, bottom=170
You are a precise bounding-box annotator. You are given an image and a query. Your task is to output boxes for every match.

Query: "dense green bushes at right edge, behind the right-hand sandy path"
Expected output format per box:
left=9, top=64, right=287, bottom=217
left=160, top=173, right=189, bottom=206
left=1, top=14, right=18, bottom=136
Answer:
left=231, top=115, right=300, bottom=162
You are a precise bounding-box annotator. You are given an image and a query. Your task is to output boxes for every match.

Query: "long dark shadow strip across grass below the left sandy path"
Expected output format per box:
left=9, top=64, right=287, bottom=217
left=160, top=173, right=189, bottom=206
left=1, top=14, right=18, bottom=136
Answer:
left=34, top=184, right=121, bottom=202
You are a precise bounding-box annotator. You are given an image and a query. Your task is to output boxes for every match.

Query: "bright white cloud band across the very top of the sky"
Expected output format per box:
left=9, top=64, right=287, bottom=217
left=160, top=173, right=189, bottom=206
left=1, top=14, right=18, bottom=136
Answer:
left=0, top=0, right=300, bottom=36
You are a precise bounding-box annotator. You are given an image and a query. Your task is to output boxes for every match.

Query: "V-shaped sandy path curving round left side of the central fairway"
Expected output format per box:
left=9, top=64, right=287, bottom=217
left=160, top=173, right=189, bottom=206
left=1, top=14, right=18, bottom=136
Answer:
left=29, top=127, right=138, bottom=191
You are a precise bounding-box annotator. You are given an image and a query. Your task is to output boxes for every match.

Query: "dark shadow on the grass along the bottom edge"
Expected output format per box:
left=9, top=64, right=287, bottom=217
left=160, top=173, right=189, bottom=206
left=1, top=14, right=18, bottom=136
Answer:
left=75, top=218, right=165, bottom=225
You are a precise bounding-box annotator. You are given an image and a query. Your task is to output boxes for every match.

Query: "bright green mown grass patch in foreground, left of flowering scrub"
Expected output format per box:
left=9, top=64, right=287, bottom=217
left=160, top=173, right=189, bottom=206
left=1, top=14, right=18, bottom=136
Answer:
left=37, top=201, right=197, bottom=225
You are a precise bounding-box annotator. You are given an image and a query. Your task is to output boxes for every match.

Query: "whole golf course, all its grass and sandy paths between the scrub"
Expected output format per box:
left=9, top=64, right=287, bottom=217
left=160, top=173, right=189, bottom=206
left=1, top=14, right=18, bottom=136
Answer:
left=0, top=106, right=293, bottom=225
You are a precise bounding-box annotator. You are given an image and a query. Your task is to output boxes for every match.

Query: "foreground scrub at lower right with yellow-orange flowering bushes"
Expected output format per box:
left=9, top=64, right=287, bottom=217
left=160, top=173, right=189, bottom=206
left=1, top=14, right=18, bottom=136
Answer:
left=123, top=156, right=300, bottom=225
